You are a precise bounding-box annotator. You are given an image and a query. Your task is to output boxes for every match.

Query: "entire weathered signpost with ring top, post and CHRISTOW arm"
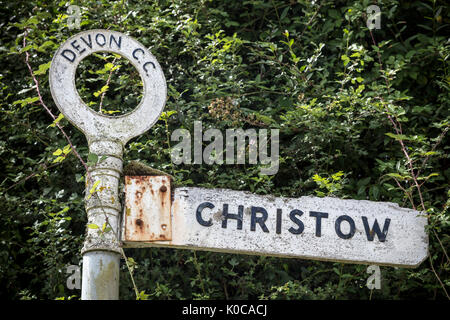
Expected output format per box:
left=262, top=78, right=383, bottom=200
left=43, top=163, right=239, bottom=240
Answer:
left=50, top=30, right=428, bottom=300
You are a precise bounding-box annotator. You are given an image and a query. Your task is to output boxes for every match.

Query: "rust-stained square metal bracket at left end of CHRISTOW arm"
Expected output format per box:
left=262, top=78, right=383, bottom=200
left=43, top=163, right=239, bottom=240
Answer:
left=124, top=176, right=172, bottom=241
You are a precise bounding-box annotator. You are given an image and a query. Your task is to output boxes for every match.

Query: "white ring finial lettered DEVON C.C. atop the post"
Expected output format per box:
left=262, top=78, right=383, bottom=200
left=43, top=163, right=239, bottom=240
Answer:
left=49, top=29, right=167, bottom=144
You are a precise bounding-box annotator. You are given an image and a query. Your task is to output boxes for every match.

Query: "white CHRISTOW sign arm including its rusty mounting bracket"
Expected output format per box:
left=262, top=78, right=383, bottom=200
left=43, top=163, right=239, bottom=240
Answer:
left=122, top=176, right=428, bottom=267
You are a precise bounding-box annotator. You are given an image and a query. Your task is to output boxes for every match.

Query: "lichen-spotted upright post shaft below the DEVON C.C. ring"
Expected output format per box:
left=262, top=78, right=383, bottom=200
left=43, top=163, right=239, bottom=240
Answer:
left=81, top=140, right=123, bottom=300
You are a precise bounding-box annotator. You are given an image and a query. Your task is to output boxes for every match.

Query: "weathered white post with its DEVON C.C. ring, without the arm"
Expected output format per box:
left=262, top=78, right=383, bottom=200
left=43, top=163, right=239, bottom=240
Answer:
left=49, top=30, right=167, bottom=300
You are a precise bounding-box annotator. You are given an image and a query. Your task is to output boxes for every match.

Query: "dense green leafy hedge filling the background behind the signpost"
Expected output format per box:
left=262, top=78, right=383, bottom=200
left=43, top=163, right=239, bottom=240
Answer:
left=0, top=0, right=450, bottom=299
